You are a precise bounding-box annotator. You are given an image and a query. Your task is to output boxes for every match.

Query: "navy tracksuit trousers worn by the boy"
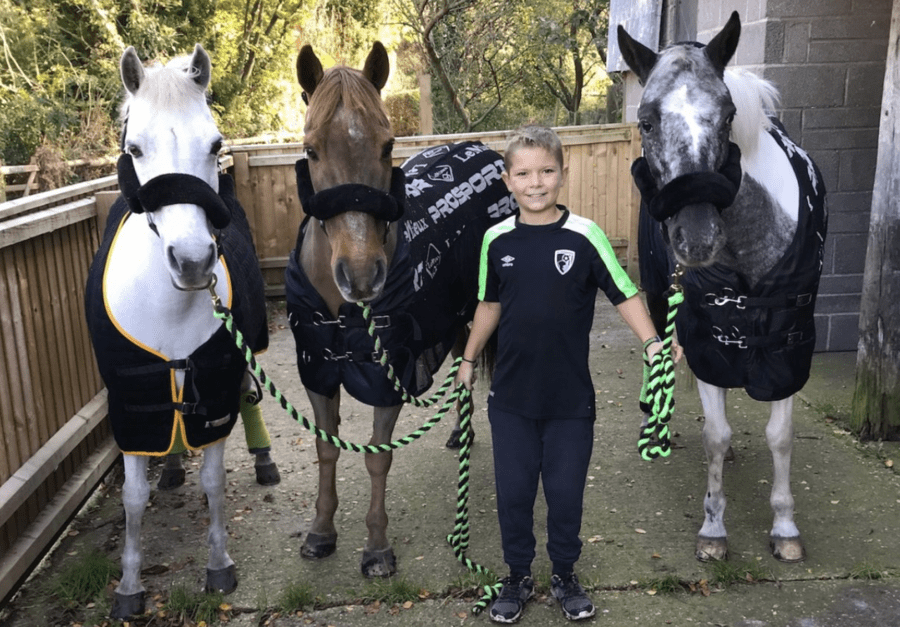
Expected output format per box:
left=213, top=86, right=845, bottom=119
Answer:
left=488, top=403, right=594, bottom=574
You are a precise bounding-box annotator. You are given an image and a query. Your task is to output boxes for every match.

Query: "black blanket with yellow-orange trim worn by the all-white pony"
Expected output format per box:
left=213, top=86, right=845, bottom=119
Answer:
left=85, top=175, right=269, bottom=455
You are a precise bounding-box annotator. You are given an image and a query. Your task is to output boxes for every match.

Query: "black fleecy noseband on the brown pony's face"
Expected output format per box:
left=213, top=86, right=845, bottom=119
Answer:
left=294, top=159, right=406, bottom=222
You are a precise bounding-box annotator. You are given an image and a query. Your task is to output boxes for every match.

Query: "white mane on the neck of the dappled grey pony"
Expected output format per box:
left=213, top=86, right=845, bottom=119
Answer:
left=725, top=68, right=780, bottom=154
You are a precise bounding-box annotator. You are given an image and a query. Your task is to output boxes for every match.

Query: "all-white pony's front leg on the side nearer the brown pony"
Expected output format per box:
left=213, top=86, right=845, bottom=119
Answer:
left=200, top=440, right=237, bottom=594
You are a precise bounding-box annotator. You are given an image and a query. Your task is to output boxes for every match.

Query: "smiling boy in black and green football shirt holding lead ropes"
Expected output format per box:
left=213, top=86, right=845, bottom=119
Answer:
left=457, top=126, right=662, bottom=623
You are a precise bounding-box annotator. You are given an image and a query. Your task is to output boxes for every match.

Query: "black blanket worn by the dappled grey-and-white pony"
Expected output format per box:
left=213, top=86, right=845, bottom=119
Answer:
left=639, top=119, right=828, bottom=401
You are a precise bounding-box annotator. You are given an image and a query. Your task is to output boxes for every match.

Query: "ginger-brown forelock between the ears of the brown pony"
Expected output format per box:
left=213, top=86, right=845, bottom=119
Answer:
left=306, top=65, right=391, bottom=133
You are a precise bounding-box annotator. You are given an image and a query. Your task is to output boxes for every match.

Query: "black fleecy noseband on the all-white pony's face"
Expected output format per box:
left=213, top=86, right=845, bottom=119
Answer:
left=117, top=154, right=234, bottom=229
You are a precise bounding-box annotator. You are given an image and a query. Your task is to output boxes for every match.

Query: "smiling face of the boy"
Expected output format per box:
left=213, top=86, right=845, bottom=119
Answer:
left=502, top=146, right=568, bottom=221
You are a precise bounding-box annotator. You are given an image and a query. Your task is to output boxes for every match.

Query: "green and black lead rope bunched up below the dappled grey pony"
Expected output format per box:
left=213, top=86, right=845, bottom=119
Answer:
left=638, top=266, right=684, bottom=461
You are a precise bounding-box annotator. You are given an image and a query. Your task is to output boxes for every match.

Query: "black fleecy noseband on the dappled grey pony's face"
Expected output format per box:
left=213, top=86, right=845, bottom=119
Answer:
left=631, top=142, right=743, bottom=222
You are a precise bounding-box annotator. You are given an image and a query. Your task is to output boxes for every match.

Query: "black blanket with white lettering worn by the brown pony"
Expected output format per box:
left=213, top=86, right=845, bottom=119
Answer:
left=285, top=142, right=516, bottom=407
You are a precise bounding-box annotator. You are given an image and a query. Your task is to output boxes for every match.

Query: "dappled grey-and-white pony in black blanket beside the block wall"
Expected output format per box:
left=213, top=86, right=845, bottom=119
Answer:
left=618, top=12, right=827, bottom=562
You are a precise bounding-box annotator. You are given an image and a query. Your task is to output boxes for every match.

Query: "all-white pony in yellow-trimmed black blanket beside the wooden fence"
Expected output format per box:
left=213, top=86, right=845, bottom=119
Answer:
left=85, top=44, right=268, bottom=619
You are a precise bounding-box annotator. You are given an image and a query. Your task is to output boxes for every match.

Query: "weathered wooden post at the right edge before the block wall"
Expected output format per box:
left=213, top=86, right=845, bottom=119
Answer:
left=851, top=0, right=900, bottom=439
